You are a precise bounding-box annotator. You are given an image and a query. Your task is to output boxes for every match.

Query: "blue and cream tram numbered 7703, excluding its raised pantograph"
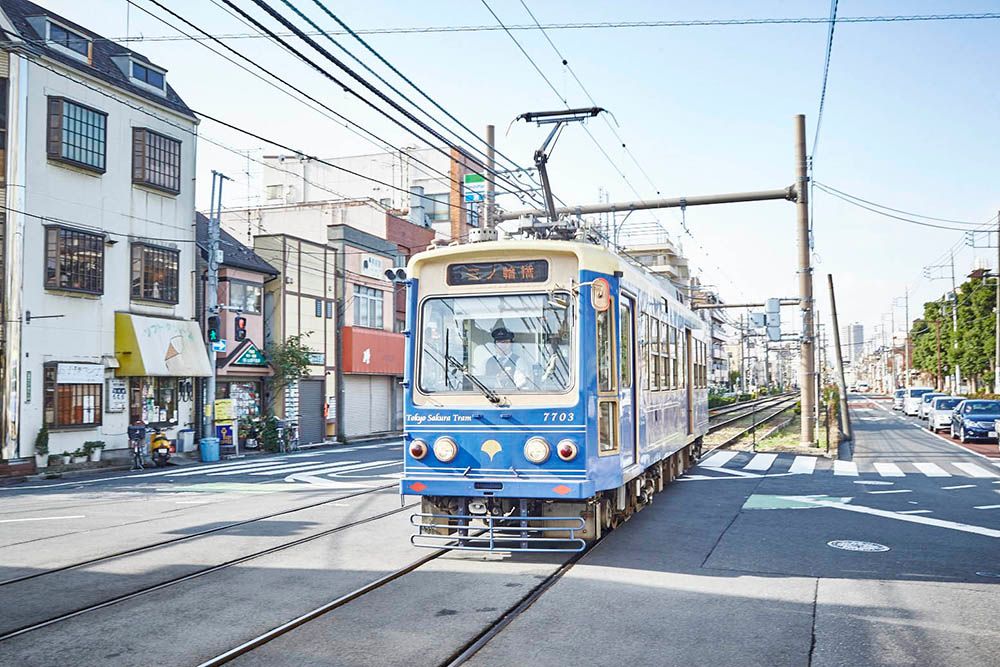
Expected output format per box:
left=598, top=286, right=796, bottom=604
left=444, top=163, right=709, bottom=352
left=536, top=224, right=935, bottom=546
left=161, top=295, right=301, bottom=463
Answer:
left=400, top=240, right=708, bottom=551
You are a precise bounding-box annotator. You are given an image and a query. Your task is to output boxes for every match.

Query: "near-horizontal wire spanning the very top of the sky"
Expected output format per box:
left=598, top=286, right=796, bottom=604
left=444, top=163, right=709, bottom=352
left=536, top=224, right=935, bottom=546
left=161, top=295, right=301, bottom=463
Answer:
left=109, top=12, right=1000, bottom=42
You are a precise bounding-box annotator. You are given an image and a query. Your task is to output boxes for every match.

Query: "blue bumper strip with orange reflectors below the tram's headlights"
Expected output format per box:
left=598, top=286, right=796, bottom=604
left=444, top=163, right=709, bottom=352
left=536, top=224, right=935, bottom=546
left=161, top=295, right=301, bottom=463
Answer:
left=399, top=475, right=596, bottom=500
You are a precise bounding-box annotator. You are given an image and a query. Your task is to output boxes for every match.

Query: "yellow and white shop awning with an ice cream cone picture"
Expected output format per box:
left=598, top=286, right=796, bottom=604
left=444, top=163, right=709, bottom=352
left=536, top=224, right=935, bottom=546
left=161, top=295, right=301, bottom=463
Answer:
left=115, top=313, right=212, bottom=377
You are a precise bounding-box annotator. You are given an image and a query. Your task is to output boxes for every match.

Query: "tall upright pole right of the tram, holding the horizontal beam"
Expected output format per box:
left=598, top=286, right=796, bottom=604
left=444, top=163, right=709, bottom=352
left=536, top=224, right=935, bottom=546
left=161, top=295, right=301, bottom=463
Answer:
left=795, top=114, right=816, bottom=446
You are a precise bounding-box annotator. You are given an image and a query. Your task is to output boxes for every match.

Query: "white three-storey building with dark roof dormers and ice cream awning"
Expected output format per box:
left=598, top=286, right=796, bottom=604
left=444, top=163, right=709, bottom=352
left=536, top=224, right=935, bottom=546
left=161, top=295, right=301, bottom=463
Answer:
left=0, top=0, right=210, bottom=470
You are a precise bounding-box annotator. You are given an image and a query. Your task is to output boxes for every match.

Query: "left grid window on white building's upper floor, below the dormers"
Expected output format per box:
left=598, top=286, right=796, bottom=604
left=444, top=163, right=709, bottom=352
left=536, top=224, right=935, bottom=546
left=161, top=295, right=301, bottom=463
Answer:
left=48, top=97, right=108, bottom=173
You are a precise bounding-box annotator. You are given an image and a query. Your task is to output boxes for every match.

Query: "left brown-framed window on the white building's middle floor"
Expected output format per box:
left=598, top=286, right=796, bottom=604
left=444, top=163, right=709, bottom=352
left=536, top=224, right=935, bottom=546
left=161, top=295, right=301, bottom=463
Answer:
left=45, top=227, right=104, bottom=294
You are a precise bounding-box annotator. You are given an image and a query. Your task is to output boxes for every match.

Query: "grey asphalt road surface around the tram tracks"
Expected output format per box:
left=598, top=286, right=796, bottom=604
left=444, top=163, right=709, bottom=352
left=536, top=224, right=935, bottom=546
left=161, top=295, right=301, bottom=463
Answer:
left=0, top=397, right=1000, bottom=666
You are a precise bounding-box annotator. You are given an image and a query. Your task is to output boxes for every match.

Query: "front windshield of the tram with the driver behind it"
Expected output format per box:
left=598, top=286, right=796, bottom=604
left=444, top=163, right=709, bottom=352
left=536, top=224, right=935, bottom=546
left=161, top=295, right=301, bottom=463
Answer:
left=419, top=292, right=575, bottom=394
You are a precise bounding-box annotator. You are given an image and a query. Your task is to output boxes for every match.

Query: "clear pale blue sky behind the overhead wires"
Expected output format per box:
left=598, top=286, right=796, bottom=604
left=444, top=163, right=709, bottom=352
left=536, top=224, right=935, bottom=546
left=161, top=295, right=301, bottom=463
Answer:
left=35, top=0, right=1000, bottom=344
